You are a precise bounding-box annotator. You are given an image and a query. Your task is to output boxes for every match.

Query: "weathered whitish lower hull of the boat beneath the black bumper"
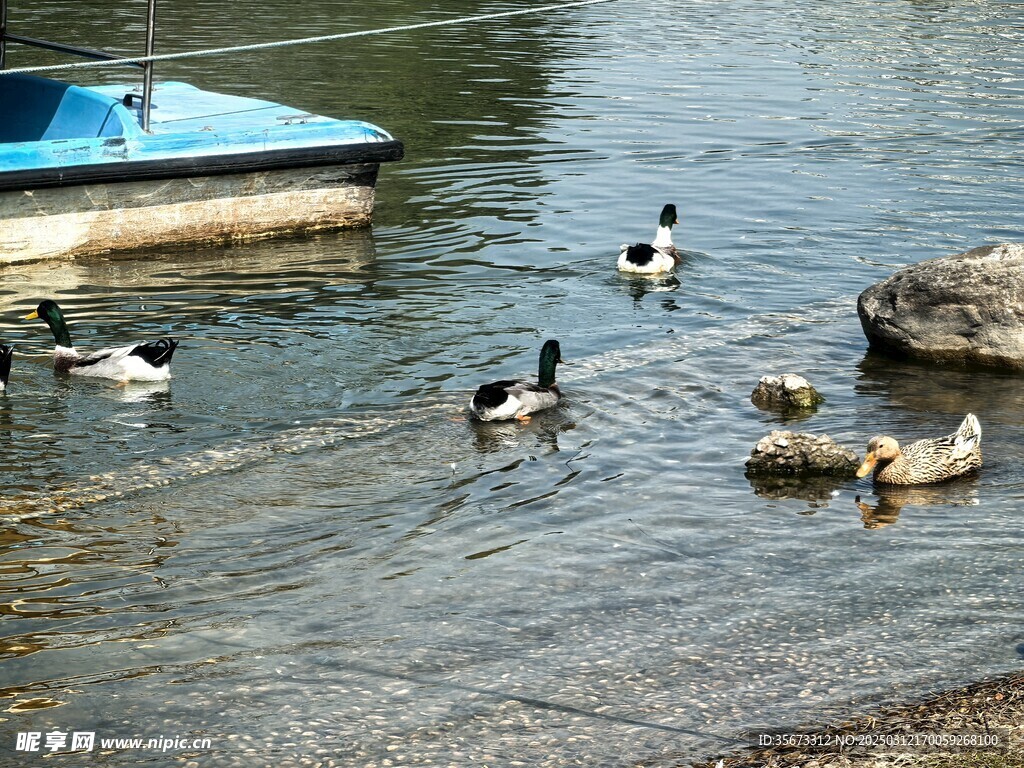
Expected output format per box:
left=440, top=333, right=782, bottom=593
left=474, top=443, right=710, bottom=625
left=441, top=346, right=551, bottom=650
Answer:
left=0, top=164, right=378, bottom=264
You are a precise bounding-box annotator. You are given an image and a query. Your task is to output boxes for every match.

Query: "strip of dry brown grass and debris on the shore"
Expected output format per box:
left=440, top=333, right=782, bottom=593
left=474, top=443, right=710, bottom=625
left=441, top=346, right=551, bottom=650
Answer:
left=696, top=673, right=1024, bottom=768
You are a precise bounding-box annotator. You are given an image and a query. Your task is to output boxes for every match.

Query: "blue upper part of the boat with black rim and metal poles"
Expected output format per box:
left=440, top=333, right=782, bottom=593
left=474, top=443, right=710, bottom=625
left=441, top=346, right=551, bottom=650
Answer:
left=0, top=0, right=403, bottom=193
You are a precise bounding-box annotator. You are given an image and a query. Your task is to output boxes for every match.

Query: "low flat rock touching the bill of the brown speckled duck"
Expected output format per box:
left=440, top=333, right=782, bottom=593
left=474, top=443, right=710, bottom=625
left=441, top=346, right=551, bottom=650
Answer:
left=746, top=430, right=859, bottom=477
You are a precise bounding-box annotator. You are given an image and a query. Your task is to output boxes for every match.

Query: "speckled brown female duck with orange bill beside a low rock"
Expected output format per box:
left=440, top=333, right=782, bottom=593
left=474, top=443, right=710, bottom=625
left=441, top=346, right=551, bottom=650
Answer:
left=857, top=414, right=981, bottom=485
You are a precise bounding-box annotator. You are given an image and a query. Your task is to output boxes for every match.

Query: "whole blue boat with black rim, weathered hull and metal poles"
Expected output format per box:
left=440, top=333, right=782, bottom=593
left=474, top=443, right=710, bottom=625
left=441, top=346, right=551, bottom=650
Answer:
left=0, top=0, right=402, bottom=264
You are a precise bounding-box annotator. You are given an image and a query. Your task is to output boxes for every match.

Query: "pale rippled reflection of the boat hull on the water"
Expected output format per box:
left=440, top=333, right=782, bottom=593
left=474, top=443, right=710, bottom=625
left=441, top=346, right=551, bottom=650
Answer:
left=0, top=229, right=379, bottom=327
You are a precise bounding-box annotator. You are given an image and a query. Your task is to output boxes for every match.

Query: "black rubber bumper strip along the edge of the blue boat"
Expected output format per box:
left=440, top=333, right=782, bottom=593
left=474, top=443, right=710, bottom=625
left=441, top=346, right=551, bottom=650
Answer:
left=0, top=139, right=406, bottom=193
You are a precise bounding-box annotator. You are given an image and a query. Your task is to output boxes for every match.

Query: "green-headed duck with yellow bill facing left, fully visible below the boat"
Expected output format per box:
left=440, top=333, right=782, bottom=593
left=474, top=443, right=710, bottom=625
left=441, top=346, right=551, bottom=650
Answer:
left=25, top=299, right=178, bottom=381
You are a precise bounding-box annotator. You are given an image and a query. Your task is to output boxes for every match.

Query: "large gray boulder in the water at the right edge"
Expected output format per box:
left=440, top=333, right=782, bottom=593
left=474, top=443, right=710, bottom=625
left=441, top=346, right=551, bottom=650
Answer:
left=857, top=243, right=1024, bottom=371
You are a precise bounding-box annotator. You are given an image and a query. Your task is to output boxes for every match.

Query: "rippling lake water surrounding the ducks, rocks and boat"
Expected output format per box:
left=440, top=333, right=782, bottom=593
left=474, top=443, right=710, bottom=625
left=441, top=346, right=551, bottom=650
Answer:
left=0, top=0, right=1024, bottom=768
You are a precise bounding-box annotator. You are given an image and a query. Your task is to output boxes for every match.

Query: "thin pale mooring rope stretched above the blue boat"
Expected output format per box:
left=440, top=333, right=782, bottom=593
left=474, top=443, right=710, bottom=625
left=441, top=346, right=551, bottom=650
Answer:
left=0, top=0, right=614, bottom=75
